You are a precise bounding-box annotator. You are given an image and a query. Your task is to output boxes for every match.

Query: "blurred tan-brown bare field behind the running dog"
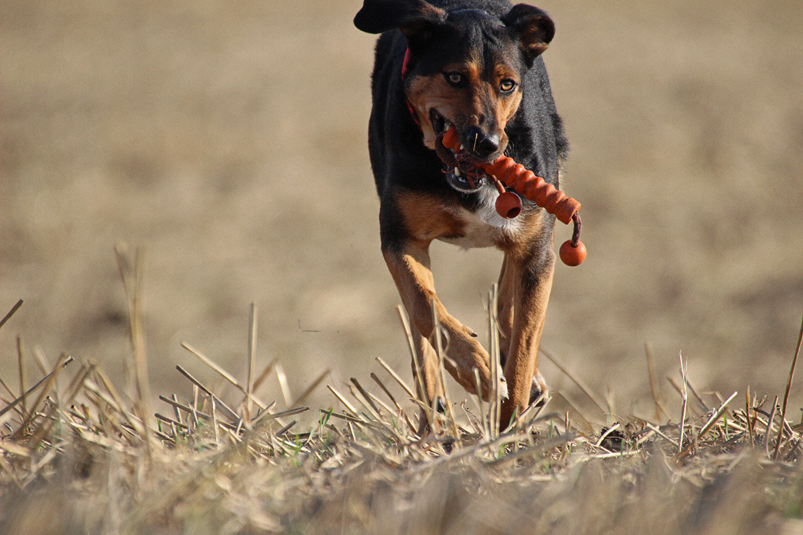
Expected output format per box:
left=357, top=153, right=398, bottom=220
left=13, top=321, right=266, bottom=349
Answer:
left=0, top=0, right=803, bottom=414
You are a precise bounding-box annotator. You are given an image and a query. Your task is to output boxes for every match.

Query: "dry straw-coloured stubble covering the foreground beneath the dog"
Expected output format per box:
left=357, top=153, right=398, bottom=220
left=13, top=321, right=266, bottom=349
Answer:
left=0, top=268, right=803, bottom=534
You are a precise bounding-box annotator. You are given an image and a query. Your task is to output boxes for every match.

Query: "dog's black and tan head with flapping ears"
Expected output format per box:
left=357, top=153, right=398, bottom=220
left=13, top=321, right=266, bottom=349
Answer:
left=354, top=0, right=555, bottom=170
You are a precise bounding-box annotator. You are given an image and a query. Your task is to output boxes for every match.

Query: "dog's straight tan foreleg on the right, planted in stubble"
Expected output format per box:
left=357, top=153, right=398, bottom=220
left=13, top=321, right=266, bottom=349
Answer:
left=499, top=248, right=555, bottom=428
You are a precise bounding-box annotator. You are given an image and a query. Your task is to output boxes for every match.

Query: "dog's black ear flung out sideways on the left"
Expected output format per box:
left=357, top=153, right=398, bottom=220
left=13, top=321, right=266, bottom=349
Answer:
left=354, top=0, right=446, bottom=39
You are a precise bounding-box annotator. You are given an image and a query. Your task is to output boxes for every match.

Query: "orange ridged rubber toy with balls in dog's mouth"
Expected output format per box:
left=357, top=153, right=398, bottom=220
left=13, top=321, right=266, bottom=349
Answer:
left=438, top=127, right=586, bottom=266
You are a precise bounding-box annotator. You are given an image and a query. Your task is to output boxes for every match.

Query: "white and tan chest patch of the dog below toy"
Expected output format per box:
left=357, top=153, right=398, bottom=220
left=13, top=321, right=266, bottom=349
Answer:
left=440, top=186, right=523, bottom=249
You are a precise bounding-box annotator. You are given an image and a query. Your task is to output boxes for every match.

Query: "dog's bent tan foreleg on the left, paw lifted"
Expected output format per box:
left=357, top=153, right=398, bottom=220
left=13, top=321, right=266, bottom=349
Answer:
left=383, top=240, right=491, bottom=399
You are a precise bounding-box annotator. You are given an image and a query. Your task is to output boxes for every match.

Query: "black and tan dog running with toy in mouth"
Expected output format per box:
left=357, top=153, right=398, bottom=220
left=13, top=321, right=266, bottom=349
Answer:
left=354, top=0, right=568, bottom=430
